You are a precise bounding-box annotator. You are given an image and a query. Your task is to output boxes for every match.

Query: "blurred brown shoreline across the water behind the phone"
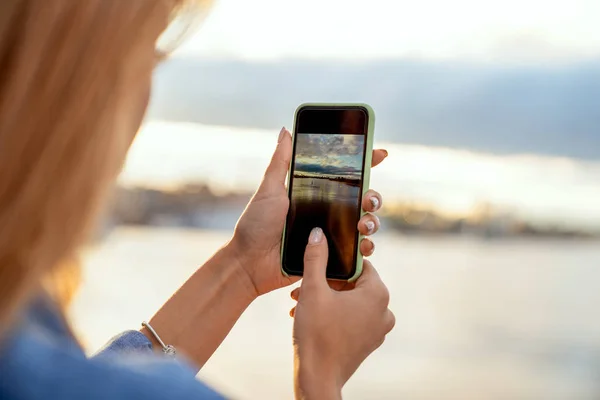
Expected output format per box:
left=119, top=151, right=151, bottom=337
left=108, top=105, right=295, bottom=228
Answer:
left=99, top=183, right=600, bottom=240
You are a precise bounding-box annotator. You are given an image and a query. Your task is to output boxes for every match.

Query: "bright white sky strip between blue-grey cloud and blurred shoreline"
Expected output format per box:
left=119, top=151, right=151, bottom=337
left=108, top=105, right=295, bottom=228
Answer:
left=121, top=122, right=600, bottom=229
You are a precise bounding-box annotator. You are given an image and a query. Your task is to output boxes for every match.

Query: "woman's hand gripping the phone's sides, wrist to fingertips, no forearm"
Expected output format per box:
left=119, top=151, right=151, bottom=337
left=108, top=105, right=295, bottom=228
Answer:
left=228, top=128, right=387, bottom=295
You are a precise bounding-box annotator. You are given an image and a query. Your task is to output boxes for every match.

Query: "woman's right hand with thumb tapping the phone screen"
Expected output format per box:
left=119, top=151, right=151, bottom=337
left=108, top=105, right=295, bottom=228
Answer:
left=292, top=228, right=395, bottom=399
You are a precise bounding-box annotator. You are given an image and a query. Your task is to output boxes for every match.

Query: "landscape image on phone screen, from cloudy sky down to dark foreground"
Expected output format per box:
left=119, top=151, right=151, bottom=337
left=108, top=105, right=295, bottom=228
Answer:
left=286, top=133, right=365, bottom=276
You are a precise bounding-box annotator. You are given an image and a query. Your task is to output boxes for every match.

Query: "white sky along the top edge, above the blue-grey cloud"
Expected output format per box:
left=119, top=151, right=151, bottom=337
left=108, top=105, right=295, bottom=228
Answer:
left=177, top=0, right=600, bottom=63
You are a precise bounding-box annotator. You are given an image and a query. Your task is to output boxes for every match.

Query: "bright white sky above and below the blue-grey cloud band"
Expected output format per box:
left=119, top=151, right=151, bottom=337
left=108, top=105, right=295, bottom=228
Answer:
left=137, top=0, right=600, bottom=230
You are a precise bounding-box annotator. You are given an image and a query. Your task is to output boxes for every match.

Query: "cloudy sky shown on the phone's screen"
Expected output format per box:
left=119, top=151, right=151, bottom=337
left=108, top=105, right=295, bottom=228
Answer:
left=295, top=134, right=364, bottom=179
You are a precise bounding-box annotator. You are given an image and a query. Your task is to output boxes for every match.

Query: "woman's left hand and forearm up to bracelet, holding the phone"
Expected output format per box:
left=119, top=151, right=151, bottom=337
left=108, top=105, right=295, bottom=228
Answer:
left=142, top=129, right=387, bottom=368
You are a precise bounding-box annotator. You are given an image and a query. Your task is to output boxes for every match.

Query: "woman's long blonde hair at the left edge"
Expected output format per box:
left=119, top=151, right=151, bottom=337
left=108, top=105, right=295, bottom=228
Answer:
left=0, top=0, right=186, bottom=334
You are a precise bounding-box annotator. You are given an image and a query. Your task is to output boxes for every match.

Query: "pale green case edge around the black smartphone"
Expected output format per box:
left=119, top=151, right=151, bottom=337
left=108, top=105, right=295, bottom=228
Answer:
left=280, top=103, right=375, bottom=282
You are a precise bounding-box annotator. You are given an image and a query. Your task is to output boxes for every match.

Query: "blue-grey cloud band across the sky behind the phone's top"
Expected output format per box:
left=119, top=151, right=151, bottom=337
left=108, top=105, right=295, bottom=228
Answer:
left=148, top=57, right=600, bottom=160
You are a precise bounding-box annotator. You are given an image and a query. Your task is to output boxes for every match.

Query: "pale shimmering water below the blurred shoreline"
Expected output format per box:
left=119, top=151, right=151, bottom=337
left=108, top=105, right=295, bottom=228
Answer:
left=70, top=227, right=600, bottom=400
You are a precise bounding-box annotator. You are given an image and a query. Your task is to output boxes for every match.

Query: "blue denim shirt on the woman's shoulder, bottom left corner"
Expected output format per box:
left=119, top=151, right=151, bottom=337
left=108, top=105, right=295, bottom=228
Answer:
left=0, top=301, right=223, bottom=400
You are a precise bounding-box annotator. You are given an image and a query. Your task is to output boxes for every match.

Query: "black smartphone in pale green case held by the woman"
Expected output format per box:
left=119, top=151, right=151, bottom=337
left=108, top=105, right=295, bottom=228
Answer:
left=281, top=104, right=375, bottom=281
